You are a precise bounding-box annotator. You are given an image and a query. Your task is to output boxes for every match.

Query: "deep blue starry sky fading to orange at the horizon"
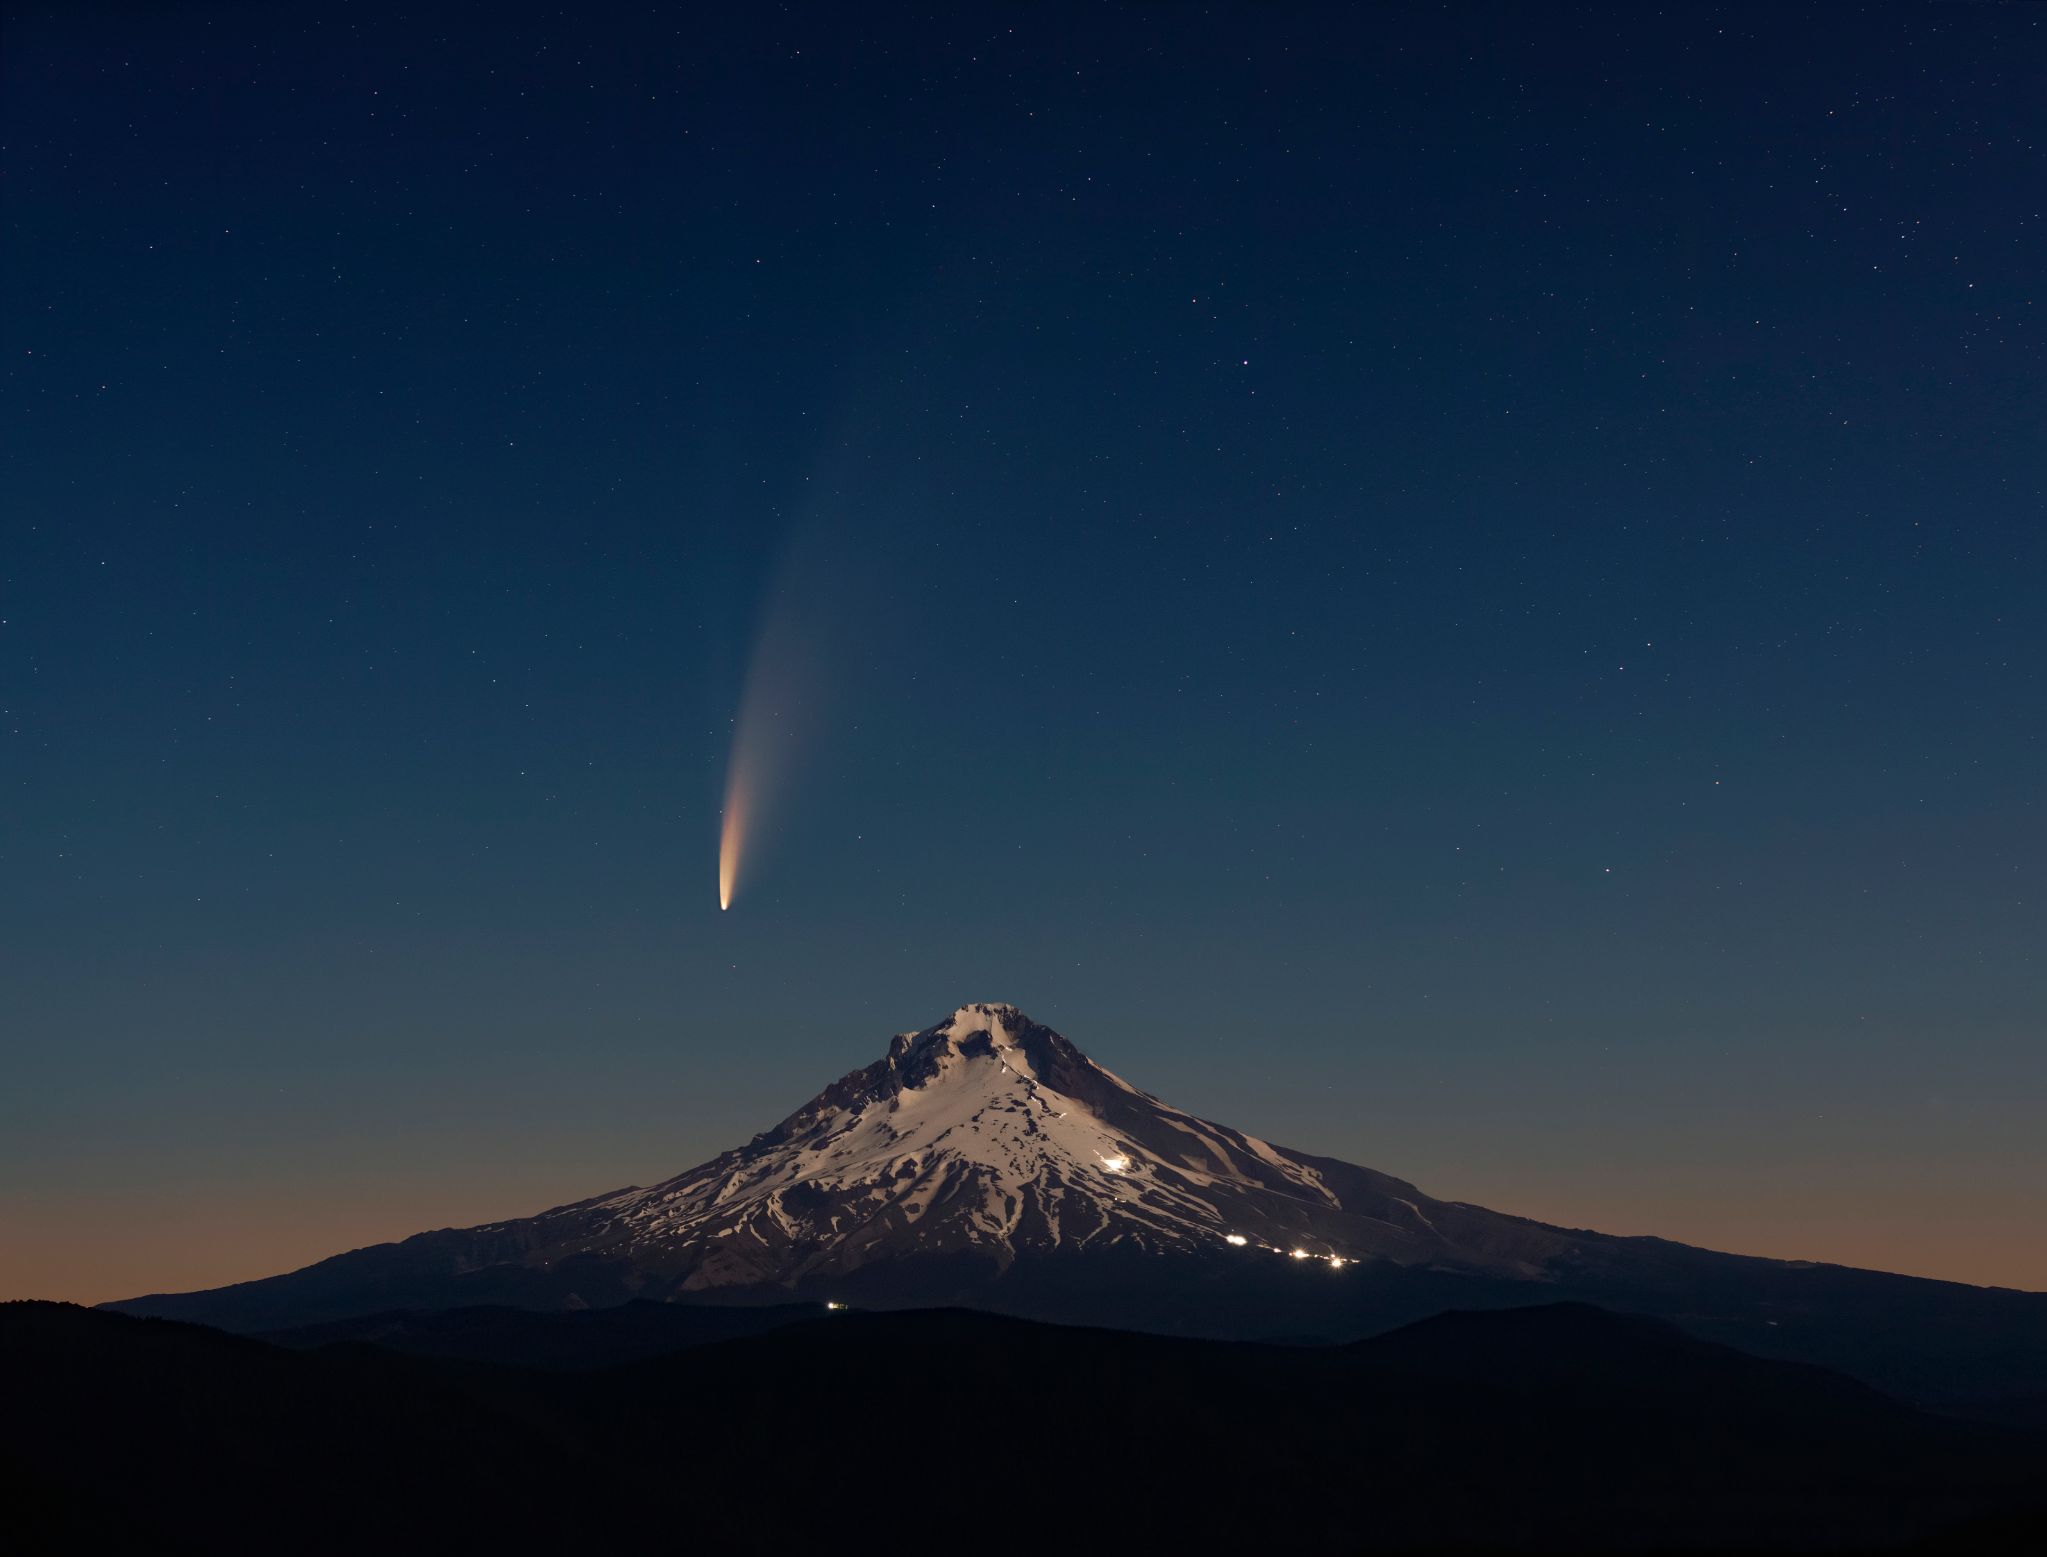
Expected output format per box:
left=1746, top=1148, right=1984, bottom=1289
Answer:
left=0, top=0, right=2047, bottom=1301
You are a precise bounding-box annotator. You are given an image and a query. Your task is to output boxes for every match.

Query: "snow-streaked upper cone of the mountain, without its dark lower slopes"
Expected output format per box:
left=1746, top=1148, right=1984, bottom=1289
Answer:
left=540, top=1005, right=1545, bottom=1291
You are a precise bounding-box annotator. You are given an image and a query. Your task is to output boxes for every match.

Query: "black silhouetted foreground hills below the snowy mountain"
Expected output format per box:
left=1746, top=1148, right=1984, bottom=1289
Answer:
left=0, top=1303, right=2047, bottom=1553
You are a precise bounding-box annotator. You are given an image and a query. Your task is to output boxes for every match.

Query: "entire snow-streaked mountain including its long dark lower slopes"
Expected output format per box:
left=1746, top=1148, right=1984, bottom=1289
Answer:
left=113, top=1005, right=2047, bottom=1397
